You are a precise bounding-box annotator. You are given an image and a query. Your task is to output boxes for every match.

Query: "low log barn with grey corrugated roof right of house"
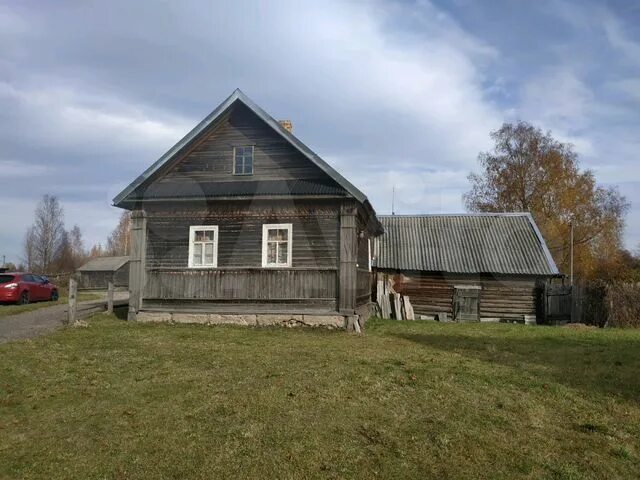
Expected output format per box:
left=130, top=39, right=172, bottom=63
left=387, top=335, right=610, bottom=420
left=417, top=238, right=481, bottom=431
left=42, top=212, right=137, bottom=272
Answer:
left=373, top=213, right=558, bottom=322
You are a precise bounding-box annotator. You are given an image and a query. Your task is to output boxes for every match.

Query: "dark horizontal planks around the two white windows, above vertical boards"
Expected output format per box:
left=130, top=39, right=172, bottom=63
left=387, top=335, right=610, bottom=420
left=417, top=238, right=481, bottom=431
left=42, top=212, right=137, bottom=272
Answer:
left=147, top=201, right=339, bottom=269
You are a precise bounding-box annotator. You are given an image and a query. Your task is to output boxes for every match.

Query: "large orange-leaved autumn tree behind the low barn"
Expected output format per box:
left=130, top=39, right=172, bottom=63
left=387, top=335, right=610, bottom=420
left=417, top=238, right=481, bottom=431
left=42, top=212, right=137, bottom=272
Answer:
left=464, top=122, right=629, bottom=278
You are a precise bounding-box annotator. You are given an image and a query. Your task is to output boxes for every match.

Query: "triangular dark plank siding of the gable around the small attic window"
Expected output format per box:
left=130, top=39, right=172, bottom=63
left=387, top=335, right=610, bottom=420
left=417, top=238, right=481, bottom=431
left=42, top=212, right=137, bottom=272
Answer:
left=158, top=104, right=327, bottom=183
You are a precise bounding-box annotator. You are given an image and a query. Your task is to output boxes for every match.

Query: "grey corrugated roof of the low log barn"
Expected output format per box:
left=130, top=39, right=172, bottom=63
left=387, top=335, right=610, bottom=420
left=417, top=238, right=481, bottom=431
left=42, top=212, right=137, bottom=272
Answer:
left=374, top=213, right=558, bottom=275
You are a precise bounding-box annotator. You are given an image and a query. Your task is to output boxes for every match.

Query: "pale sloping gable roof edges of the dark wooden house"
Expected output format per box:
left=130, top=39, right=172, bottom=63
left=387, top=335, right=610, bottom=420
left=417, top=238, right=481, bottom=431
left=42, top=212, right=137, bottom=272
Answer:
left=113, top=89, right=372, bottom=210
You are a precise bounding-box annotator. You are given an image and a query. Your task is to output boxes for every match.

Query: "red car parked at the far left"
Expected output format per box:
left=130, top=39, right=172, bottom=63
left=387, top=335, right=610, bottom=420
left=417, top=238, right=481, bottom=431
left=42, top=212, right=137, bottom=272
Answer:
left=0, top=272, right=58, bottom=305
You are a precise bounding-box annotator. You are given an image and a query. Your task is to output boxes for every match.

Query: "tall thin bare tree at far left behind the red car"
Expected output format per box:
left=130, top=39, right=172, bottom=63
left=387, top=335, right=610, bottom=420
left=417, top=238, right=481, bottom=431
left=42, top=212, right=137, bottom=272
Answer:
left=24, top=194, right=66, bottom=272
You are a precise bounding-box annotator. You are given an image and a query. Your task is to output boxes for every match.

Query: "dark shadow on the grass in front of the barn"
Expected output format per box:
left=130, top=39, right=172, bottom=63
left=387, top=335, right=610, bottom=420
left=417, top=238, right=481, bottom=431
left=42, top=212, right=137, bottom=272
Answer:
left=395, top=332, right=640, bottom=402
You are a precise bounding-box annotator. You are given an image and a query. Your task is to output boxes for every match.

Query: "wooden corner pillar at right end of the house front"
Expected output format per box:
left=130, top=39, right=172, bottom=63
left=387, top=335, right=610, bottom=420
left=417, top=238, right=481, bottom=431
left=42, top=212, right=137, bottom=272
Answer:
left=338, top=203, right=358, bottom=315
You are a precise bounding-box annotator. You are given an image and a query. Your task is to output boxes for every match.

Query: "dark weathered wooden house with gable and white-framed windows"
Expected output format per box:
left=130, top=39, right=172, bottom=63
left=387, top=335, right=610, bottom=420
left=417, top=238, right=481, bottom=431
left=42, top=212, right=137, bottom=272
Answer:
left=114, top=90, right=383, bottom=328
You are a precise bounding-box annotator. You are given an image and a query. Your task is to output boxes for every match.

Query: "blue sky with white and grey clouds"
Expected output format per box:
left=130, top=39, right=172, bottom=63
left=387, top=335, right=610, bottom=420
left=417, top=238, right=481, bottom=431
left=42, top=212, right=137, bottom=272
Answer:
left=0, top=0, right=640, bottom=261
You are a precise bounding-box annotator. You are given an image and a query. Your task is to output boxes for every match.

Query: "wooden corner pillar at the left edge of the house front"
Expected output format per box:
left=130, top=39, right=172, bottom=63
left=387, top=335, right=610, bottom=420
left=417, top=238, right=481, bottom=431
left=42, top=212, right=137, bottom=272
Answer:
left=127, top=210, right=147, bottom=321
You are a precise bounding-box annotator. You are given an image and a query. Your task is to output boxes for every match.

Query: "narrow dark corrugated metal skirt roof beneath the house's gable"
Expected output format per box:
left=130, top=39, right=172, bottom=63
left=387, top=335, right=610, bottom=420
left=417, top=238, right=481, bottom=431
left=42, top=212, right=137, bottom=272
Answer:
left=133, top=180, right=347, bottom=199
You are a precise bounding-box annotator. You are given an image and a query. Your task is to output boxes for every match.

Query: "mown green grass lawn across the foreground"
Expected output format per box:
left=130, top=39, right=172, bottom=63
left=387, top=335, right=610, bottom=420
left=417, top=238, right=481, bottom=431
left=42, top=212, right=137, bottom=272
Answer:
left=0, top=314, right=640, bottom=479
